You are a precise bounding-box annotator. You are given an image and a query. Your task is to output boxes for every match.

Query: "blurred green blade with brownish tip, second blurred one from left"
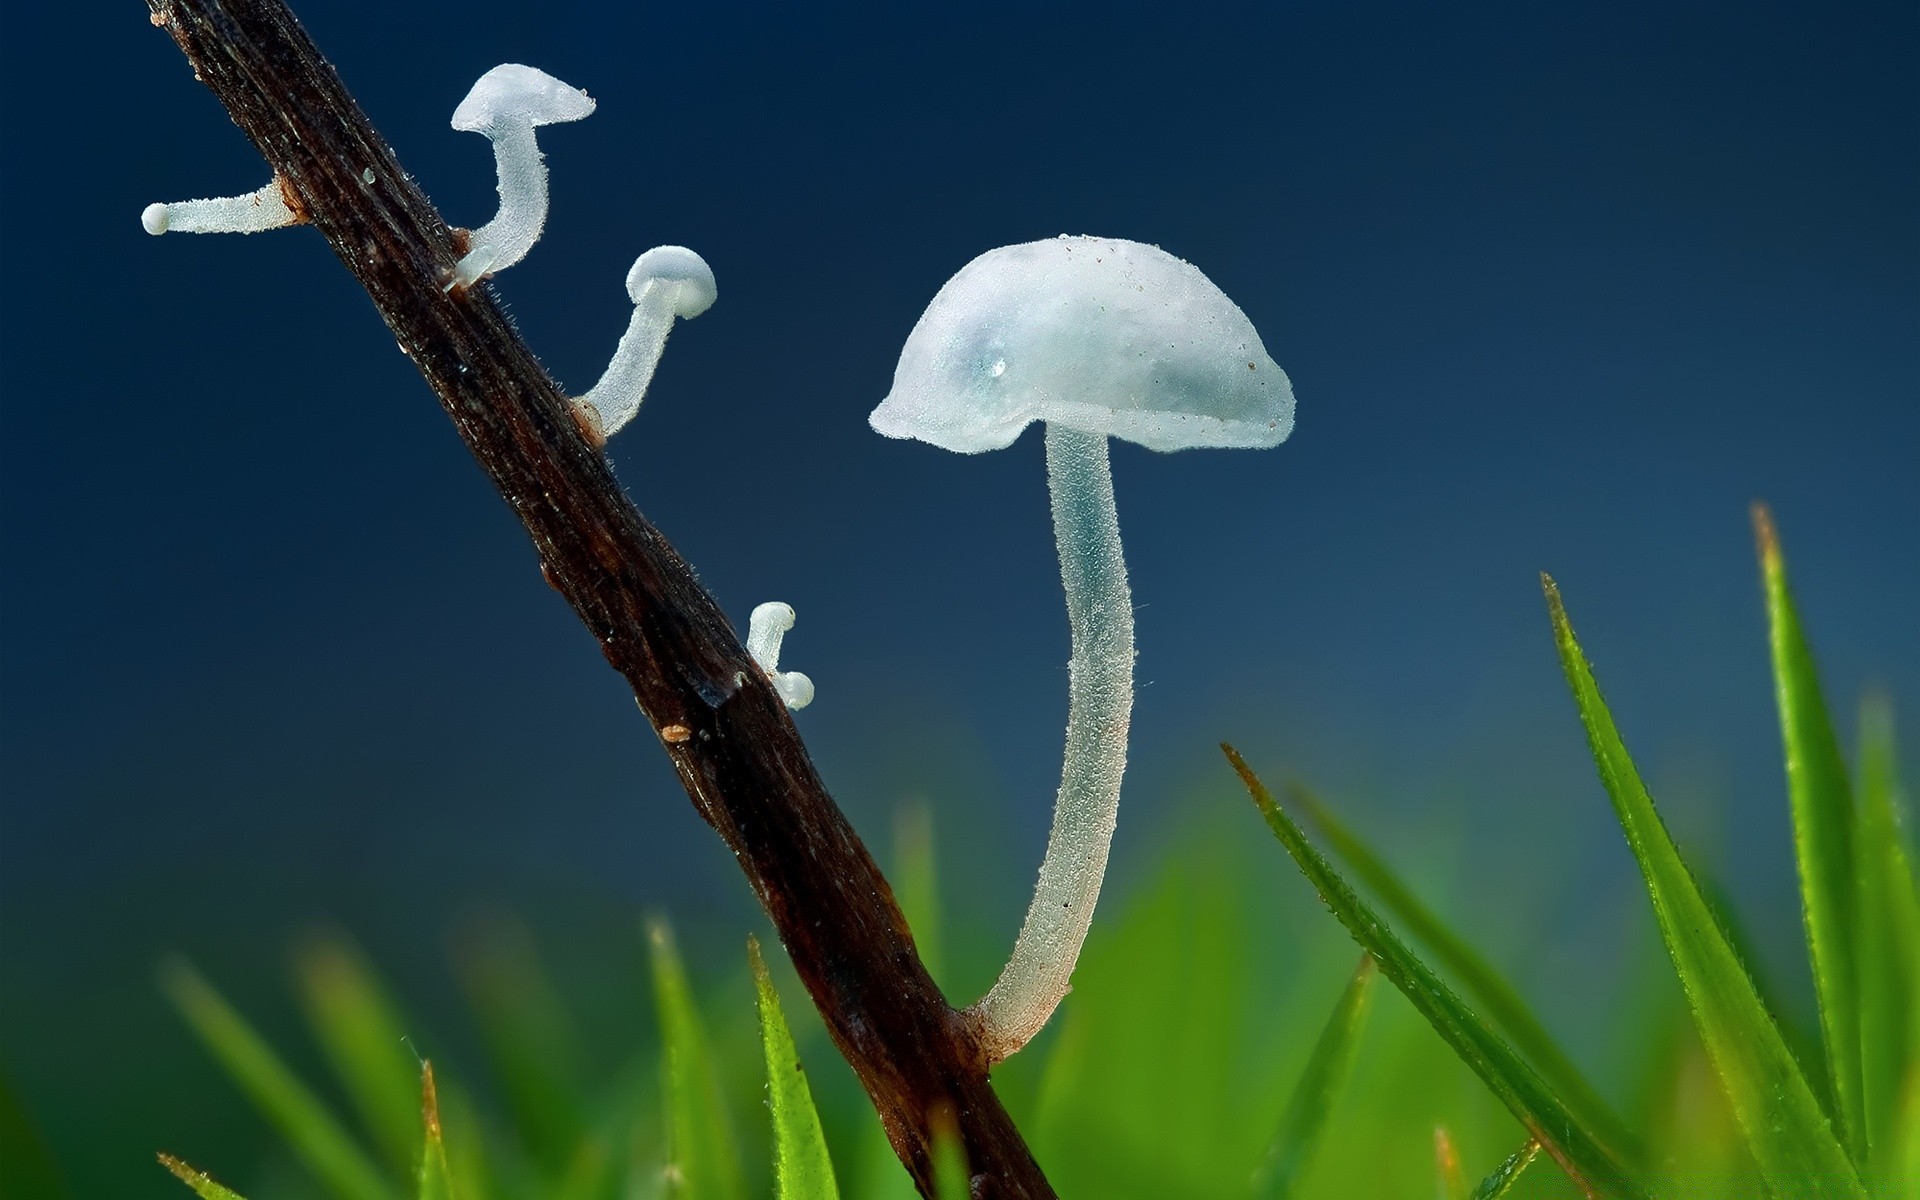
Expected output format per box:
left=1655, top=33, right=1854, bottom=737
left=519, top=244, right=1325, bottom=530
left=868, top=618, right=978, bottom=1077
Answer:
left=294, top=935, right=420, bottom=1173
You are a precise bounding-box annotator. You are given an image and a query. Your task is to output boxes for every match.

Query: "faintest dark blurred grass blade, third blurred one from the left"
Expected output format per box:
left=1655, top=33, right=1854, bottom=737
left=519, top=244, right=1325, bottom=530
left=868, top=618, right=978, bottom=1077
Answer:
left=459, top=920, right=588, bottom=1179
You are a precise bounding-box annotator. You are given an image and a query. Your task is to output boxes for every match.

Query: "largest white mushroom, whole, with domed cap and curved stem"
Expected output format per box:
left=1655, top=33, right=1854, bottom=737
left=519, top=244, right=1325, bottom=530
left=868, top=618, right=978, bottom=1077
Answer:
left=868, top=236, right=1294, bottom=1062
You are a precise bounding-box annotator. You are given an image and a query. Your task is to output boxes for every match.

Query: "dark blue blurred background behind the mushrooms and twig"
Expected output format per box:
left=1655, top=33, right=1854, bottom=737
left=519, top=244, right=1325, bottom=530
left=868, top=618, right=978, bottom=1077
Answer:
left=0, top=0, right=1920, bottom=1194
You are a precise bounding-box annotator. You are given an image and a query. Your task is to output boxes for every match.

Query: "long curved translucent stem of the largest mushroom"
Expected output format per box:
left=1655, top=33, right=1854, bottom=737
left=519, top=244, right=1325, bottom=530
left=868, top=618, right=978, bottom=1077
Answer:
left=966, top=422, right=1133, bottom=1064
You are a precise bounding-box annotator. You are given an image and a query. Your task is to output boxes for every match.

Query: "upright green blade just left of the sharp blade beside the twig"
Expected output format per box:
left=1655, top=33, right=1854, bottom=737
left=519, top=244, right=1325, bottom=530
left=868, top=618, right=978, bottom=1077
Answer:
left=649, top=922, right=747, bottom=1200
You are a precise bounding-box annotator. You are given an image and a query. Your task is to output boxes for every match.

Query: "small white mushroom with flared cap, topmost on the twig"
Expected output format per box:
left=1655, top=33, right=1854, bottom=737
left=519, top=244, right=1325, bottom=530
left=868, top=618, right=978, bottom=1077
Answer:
left=447, top=63, right=593, bottom=290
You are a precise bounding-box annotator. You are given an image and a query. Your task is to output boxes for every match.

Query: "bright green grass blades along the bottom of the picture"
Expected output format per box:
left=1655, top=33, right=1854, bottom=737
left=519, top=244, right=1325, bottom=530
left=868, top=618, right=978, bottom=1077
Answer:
left=142, top=511, right=1920, bottom=1200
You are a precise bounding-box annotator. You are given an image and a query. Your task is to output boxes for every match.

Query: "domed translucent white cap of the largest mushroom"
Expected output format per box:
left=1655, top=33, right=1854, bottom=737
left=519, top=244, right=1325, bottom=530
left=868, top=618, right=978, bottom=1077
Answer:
left=868, top=234, right=1294, bottom=453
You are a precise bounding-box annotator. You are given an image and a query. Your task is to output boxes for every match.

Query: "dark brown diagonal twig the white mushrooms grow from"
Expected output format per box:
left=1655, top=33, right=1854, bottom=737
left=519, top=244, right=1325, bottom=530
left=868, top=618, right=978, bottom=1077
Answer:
left=150, top=0, right=1054, bottom=1198
